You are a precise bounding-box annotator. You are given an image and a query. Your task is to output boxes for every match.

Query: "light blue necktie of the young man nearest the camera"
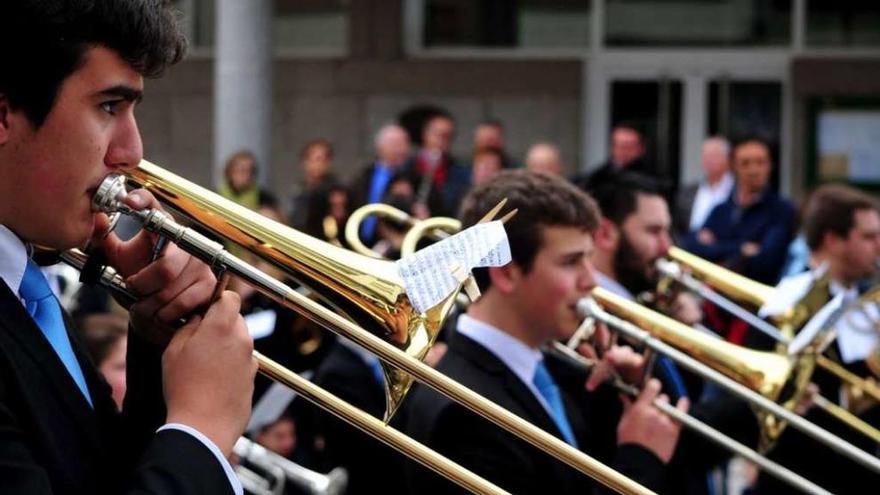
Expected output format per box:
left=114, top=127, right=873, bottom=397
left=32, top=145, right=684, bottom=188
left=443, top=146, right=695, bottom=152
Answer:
left=18, top=260, right=92, bottom=406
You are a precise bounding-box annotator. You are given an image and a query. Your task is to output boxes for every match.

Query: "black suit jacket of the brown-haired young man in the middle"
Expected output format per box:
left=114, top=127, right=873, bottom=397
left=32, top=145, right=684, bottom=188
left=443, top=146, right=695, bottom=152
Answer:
left=406, top=334, right=662, bottom=495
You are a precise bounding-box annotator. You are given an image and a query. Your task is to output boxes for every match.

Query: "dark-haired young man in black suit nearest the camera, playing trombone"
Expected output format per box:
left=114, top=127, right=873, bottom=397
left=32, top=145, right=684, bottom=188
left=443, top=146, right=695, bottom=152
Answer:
left=0, top=0, right=255, bottom=495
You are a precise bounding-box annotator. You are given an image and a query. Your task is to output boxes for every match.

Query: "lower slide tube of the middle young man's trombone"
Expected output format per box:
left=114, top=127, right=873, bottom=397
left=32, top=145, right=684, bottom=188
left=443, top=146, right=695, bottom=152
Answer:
left=550, top=341, right=831, bottom=495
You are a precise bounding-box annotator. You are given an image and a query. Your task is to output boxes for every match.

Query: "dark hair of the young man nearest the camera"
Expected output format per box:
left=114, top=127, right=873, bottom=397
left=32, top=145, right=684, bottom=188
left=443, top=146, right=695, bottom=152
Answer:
left=0, top=0, right=186, bottom=127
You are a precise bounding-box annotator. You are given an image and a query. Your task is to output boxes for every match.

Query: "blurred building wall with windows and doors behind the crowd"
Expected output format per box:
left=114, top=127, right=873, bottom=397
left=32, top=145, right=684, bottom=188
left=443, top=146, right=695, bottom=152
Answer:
left=139, top=0, right=880, bottom=200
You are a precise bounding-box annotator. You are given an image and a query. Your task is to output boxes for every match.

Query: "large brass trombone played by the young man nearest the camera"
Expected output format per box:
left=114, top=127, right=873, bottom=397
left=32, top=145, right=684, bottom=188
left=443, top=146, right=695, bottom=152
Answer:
left=86, top=161, right=650, bottom=493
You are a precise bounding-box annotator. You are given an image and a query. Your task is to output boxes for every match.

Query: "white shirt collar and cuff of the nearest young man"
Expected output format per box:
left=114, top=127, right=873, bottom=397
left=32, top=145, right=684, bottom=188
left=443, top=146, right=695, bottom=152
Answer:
left=0, top=224, right=244, bottom=495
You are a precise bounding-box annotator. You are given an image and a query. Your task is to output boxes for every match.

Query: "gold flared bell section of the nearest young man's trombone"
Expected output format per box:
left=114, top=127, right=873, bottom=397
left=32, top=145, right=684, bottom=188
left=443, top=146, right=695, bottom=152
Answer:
left=128, top=160, right=455, bottom=422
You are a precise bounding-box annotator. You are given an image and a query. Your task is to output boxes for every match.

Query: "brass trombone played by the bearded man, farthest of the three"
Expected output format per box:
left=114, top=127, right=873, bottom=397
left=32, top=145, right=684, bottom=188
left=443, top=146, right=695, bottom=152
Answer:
left=658, top=247, right=880, bottom=443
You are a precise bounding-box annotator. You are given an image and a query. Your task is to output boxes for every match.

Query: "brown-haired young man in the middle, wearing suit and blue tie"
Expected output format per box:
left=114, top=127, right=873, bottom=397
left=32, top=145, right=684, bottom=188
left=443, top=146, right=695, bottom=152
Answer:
left=406, top=170, right=679, bottom=494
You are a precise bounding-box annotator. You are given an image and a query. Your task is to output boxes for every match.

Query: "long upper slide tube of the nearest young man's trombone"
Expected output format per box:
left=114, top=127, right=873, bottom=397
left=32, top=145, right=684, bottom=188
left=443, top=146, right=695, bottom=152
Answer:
left=98, top=202, right=652, bottom=494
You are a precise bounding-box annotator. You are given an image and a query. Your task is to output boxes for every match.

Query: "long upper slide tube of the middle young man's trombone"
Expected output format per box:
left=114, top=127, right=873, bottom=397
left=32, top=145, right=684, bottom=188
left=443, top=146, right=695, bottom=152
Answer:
left=578, top=288, right=880, bottom=473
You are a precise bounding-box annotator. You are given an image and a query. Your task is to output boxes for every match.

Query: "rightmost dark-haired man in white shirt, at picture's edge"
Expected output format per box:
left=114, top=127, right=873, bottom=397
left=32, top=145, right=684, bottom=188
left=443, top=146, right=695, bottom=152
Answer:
left=755, top=184, right=880, bottom=494
